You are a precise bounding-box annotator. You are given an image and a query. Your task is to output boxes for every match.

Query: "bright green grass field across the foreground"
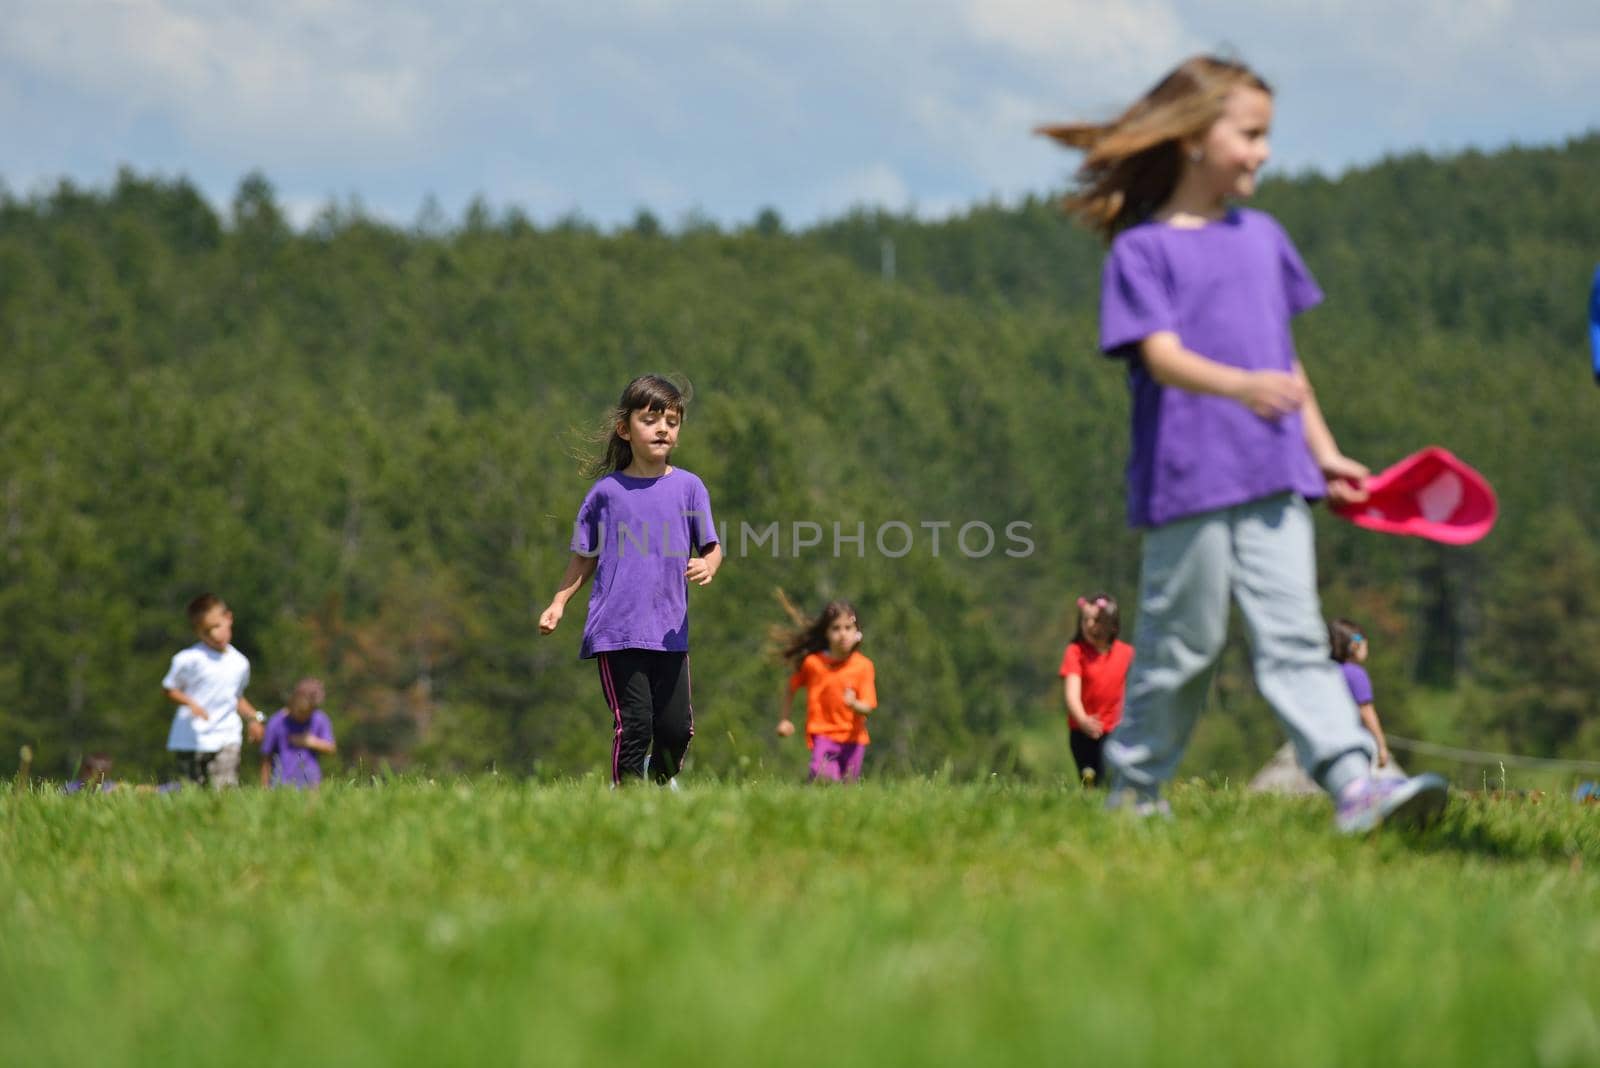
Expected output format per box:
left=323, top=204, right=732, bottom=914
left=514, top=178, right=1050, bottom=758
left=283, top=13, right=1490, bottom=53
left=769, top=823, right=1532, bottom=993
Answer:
left=0, top=779, right=1600, bottom=1066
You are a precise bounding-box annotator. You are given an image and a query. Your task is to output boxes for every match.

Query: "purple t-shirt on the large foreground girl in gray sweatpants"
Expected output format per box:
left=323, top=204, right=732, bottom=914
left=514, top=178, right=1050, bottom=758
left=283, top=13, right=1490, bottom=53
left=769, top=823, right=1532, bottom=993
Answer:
left=1101, top=209, right=1326, bottom=526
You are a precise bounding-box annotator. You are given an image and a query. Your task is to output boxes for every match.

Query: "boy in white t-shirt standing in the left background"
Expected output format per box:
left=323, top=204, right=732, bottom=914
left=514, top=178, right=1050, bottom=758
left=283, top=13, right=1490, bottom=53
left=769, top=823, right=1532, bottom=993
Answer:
left=162, top=593, right=264, bottom=790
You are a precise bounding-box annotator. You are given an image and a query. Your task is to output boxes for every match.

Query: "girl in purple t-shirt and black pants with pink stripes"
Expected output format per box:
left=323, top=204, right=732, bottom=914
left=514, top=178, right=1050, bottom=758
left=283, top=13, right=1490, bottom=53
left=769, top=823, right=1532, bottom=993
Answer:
left=539, top=374, right=722, bottom=785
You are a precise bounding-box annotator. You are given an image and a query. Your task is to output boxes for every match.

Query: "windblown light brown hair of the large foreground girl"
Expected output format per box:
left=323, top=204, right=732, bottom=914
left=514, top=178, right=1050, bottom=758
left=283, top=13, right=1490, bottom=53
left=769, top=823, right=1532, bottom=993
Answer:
left=1034, top=56, right=1272, bottom=241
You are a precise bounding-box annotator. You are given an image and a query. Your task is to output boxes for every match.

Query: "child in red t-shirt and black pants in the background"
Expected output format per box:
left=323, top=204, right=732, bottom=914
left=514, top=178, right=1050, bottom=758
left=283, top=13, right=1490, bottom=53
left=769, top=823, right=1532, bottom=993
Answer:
left=1061, top=593, right=1133, bottom=787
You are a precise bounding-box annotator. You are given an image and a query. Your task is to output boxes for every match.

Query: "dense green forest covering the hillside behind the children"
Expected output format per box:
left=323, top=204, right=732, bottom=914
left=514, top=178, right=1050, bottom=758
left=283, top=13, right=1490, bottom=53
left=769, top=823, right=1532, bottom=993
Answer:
left=0, top=136, right=1600, bottom=775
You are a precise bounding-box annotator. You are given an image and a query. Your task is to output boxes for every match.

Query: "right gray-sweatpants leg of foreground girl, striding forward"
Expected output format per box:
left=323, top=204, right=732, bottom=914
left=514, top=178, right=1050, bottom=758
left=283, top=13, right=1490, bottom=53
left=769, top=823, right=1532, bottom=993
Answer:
left=1234, top=494, right=1374, bottom=796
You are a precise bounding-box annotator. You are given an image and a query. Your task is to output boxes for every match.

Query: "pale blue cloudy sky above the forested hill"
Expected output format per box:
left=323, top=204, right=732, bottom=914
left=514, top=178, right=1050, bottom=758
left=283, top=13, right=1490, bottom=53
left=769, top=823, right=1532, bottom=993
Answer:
left=0, top=0, right=1600, bottom=225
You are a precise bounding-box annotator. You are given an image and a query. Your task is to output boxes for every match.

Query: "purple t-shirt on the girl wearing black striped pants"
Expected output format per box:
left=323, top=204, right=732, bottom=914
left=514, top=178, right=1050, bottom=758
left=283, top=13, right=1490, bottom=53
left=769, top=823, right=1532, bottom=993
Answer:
left=571, top=467, right=717, bottom=659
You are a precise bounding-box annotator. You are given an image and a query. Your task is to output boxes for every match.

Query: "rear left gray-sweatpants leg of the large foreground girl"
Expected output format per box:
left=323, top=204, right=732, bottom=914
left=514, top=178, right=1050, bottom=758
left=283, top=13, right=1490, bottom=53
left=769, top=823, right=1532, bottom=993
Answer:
left=1104, top=512, right=1232, bottom=798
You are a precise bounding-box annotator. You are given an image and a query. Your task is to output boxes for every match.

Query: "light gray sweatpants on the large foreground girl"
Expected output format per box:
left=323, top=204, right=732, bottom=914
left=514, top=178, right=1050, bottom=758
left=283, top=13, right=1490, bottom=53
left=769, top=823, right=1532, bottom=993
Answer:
left=1106, top=492, right=1374, bottom=798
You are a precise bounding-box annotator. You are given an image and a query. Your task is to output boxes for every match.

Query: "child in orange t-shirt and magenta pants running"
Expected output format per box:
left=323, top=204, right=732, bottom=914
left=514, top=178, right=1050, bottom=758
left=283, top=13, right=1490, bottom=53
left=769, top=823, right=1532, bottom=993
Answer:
left=778, top=601, right=878, bottom=782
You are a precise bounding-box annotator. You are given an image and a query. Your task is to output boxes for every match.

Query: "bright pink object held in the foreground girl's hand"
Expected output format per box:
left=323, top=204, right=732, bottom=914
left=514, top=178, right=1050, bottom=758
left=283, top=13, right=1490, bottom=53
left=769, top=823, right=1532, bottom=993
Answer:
left=1333, top=444, right=1499, bottom=545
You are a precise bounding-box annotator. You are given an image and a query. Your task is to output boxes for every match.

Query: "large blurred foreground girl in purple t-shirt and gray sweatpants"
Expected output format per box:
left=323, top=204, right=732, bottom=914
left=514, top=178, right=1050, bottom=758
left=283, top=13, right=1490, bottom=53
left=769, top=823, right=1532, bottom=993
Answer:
left=1040, top=56, right=1446, bottom=833
